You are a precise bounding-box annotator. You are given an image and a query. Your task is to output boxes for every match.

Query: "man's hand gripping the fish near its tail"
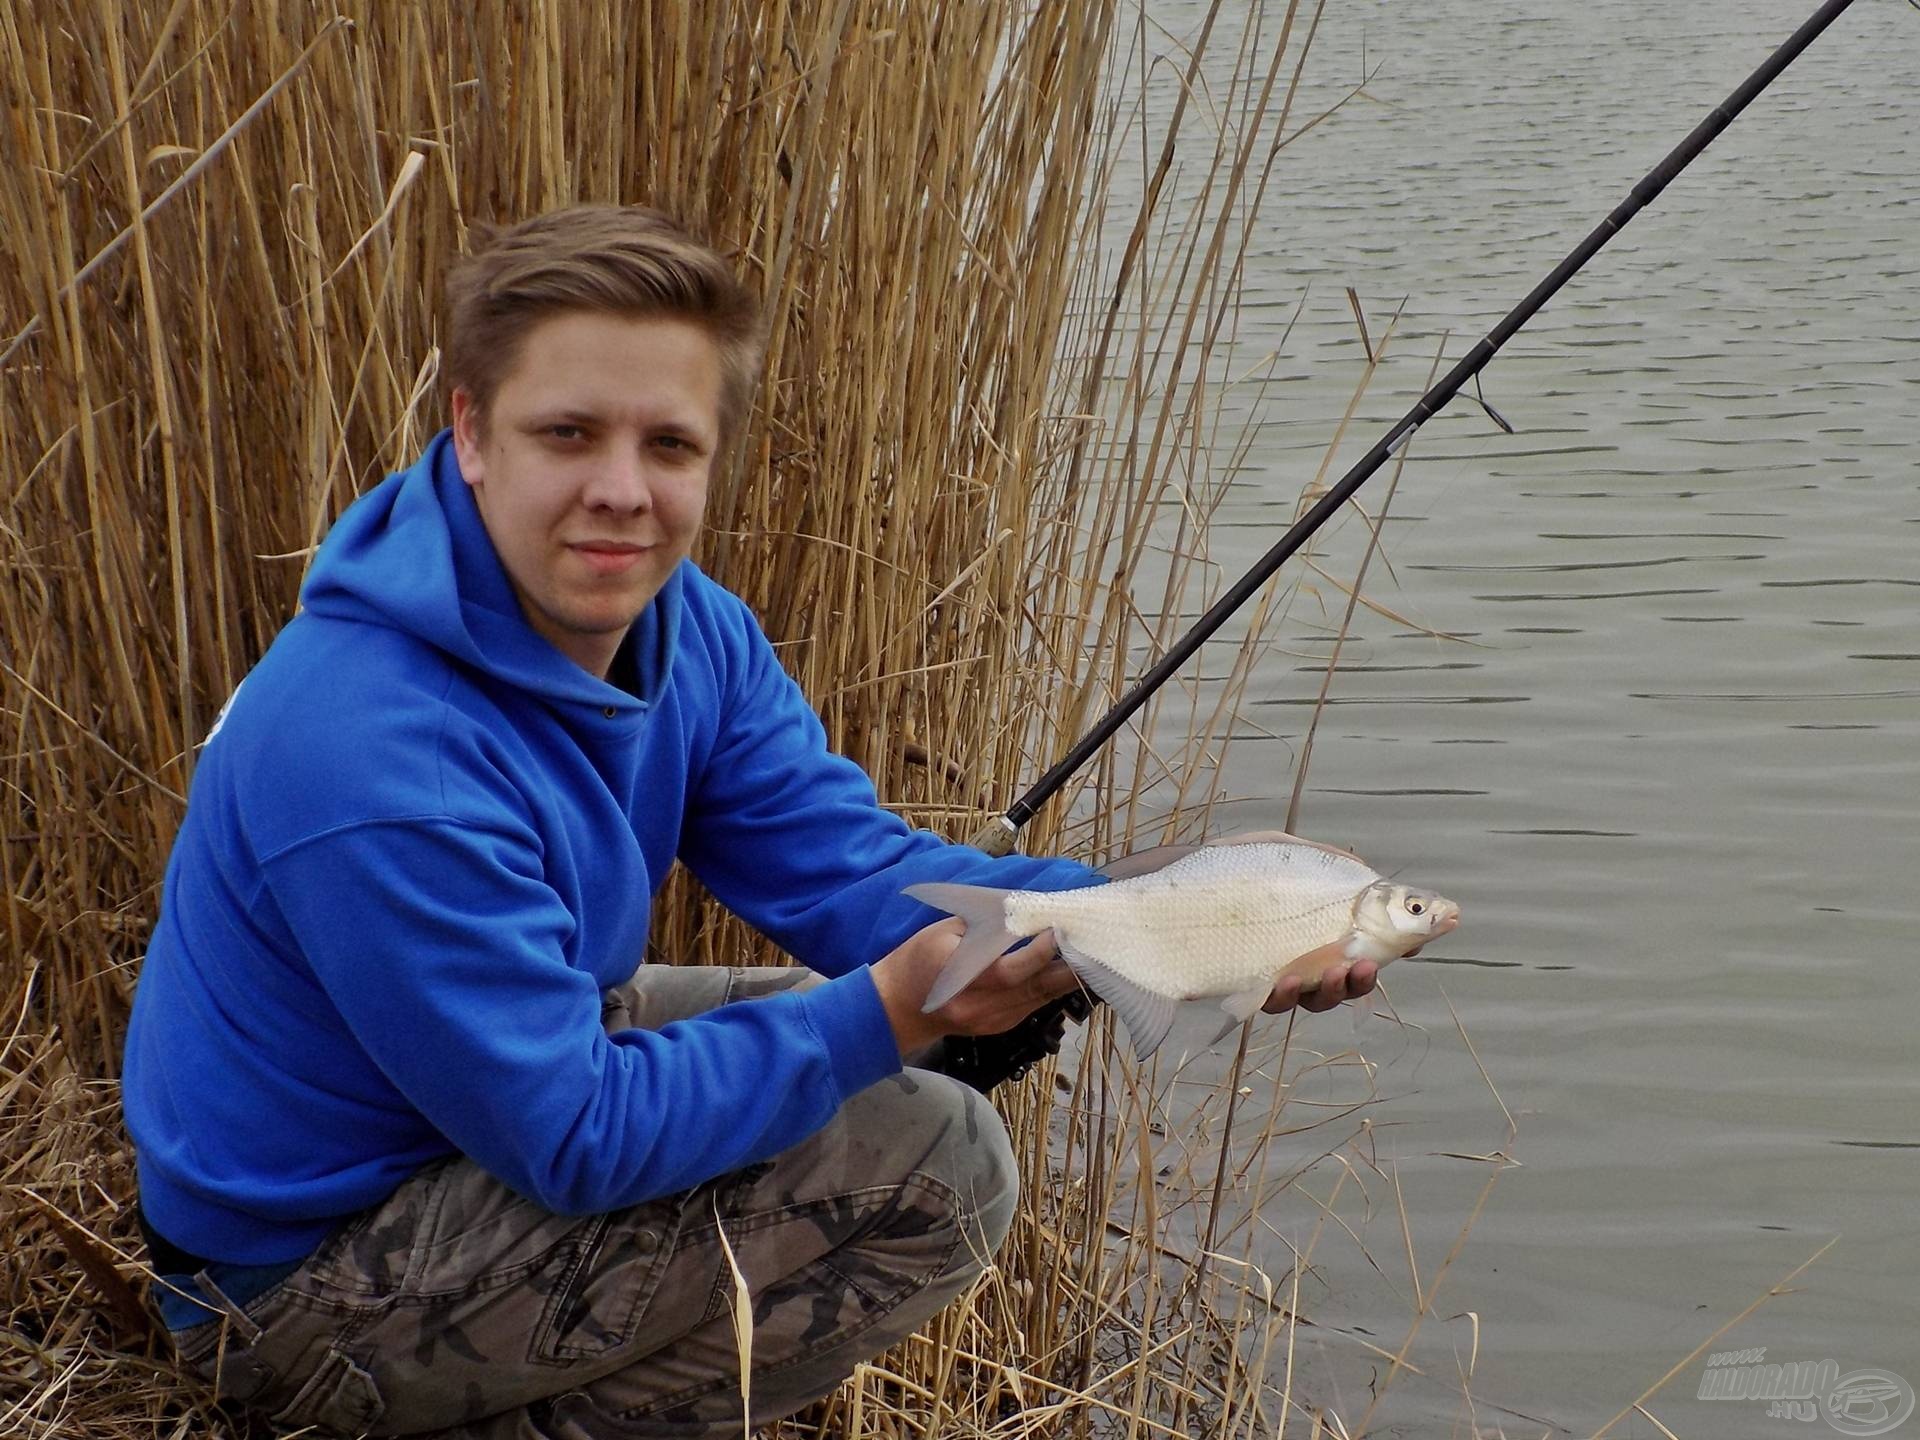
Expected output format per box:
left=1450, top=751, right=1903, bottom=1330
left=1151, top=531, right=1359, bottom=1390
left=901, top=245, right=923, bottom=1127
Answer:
left=874, top=920, right=1079, bottom=1056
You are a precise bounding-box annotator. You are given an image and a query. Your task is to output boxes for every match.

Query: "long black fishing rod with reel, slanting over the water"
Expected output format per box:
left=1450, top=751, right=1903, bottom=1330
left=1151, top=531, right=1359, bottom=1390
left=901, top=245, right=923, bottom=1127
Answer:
left=936, top=0, right=1853, bottom=1079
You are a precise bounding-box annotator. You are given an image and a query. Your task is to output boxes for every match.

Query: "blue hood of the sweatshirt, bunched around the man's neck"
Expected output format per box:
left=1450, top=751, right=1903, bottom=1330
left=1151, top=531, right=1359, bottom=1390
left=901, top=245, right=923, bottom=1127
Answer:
left=300, top=430, right=687, bottom=707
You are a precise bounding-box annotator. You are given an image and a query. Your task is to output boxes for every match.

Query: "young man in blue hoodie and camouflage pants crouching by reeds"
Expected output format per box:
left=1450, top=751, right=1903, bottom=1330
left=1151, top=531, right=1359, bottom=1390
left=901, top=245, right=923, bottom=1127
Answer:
left=125, top=207, right=1371, bottom=1440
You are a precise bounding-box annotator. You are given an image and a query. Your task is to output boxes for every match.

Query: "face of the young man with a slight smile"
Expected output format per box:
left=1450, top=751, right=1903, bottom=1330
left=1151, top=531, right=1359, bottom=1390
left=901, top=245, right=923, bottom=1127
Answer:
left=453, top=311, right=720, bottom=676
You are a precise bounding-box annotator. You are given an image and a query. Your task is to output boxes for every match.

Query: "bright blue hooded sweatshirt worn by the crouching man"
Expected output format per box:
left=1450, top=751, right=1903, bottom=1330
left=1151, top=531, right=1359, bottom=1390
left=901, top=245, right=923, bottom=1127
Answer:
left=125, top=432, right=1094, bottom=1265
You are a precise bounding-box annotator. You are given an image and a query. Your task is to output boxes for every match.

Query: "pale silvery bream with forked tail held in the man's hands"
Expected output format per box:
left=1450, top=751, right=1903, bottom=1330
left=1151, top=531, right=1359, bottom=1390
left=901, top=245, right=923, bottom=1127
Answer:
left=906, top=835, right=1459, bottom=1060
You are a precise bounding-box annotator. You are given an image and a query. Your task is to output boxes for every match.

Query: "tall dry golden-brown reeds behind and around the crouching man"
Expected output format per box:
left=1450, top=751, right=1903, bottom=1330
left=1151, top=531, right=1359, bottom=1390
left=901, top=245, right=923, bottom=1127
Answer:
left=0, top=0, right=1497, bottom=1440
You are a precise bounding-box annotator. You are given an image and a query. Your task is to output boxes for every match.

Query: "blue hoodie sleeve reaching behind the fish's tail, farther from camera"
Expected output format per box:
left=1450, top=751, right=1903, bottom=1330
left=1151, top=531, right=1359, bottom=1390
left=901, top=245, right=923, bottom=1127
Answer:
left=680, top=588, right=1102, bottom=975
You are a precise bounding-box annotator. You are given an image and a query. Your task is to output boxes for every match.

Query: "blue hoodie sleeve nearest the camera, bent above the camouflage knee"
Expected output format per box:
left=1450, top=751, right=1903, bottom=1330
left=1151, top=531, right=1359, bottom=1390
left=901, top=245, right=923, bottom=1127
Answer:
left=267, top=820, right=899, bottom=1215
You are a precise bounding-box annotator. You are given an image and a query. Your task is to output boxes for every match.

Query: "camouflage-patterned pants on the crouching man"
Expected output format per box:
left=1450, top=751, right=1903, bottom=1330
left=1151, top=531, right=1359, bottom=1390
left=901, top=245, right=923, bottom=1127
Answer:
left=177, top=966, right=1018, bottom=1440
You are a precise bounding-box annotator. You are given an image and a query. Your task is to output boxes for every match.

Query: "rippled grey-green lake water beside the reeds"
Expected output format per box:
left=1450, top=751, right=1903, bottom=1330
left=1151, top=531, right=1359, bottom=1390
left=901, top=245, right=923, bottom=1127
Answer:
left=1113, top=0, right=1920, bottom=1440
